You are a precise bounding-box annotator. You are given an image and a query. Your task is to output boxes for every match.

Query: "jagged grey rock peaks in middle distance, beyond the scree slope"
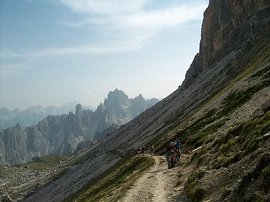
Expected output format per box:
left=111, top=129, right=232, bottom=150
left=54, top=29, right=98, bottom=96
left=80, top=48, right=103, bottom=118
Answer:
left=0, top=89, right=157, bottom=164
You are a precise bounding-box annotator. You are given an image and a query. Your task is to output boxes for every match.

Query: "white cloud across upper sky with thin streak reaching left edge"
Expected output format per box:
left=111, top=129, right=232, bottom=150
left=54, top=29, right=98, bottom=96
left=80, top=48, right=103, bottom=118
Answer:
left=0, top=0, right=206, bottom=59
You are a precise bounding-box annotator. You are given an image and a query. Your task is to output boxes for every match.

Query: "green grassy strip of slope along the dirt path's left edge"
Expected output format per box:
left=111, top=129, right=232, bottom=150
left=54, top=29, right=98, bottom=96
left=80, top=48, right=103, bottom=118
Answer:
left=68, top=156, right=155, bottom=201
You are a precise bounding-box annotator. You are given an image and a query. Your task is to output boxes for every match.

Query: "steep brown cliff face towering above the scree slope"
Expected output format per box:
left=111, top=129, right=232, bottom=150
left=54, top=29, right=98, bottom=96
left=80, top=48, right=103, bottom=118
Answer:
left=183, top=0, right=270, bottom=87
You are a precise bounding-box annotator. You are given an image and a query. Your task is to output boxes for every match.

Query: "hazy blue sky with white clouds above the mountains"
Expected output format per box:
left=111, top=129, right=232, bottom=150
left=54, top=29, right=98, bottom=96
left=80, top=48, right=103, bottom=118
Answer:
left=0, top=0, right=208, bottom=109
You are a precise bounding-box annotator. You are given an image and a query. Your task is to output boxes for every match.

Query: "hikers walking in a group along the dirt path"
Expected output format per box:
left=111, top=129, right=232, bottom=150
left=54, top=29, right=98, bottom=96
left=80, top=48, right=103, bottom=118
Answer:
left=135, top=139, right=181, bottom=169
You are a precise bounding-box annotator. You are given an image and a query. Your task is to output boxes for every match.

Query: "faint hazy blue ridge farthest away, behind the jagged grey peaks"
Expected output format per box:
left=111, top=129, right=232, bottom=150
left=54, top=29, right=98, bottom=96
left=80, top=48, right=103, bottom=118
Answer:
left=0, top=101, right=92, bottom=129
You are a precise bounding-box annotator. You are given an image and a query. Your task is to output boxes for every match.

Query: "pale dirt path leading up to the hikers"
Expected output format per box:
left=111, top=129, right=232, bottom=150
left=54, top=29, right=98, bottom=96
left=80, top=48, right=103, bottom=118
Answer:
left=120, top=156, right=177, bottom=202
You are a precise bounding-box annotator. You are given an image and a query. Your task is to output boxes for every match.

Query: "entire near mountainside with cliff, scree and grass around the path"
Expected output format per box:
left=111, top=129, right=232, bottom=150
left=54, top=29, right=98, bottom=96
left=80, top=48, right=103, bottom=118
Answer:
left=1, top=0, right=270, bottom=201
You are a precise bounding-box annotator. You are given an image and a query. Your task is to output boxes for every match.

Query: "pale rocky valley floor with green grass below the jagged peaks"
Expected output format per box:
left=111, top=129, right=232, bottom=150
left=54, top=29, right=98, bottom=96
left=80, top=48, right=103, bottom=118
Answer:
left=0, top=143, right=99, bottom=201
